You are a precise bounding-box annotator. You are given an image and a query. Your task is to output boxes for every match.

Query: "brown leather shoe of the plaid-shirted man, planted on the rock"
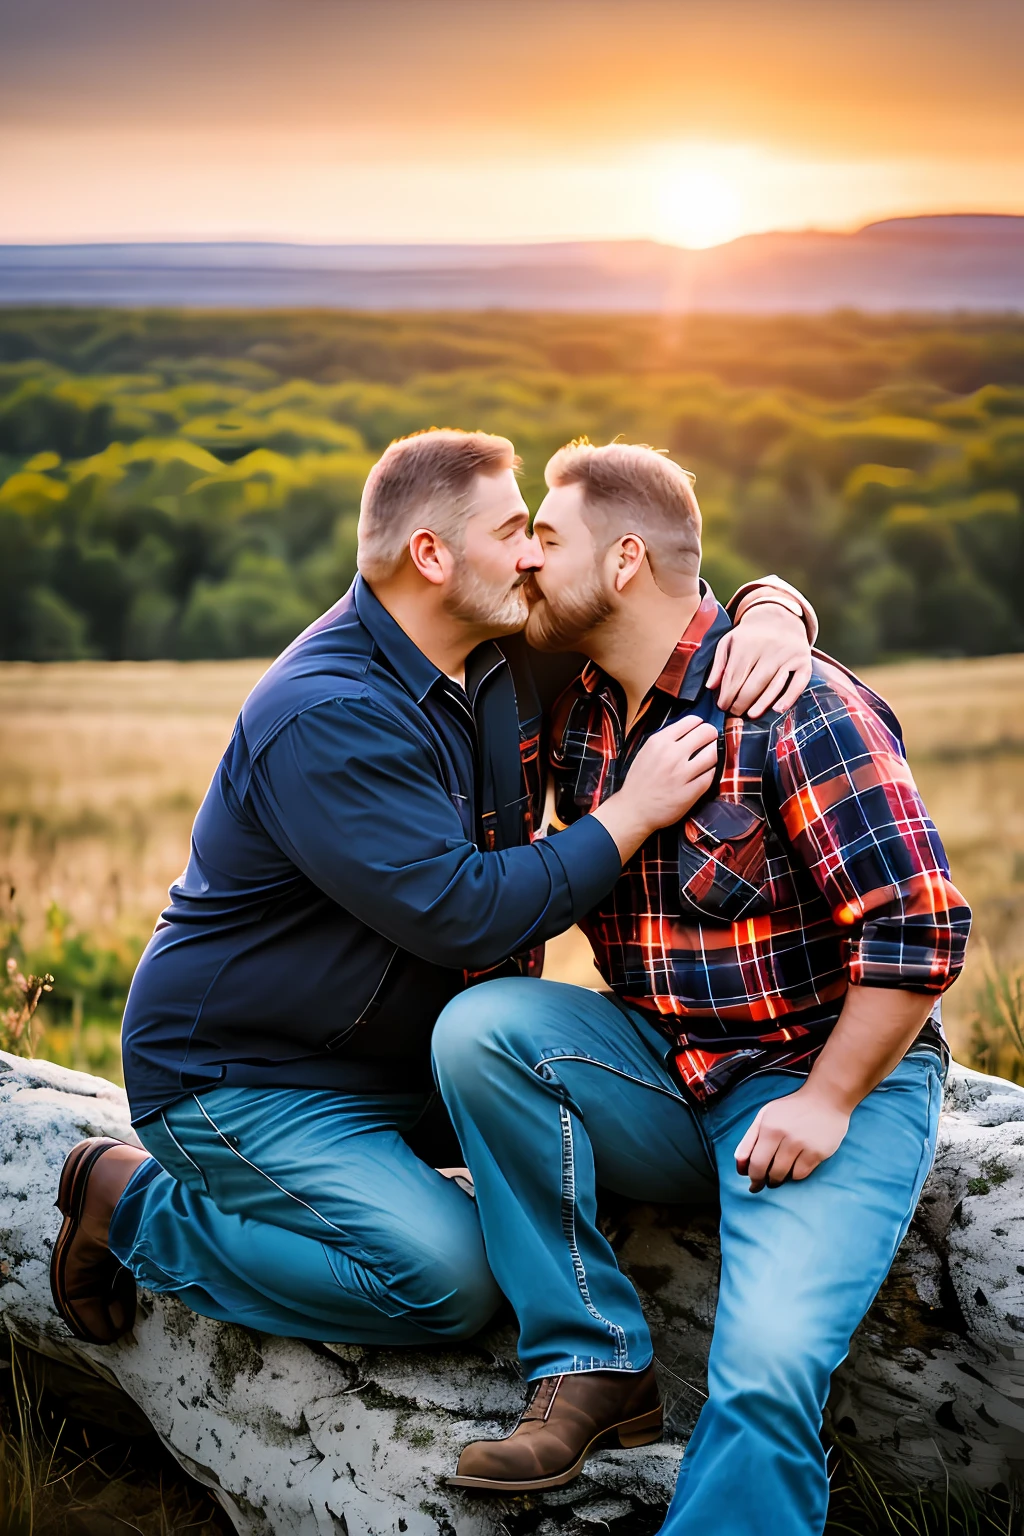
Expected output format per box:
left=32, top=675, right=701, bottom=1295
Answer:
left=447, top=1366, right=663, bottom=1493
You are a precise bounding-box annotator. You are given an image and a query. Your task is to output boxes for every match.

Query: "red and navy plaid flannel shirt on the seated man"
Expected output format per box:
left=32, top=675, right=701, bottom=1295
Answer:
left=550, top=590, right=970, bottom=1098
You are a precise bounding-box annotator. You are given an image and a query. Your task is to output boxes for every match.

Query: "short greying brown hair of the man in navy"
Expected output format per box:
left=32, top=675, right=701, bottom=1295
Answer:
left=356, top=427, right=519, bottom=581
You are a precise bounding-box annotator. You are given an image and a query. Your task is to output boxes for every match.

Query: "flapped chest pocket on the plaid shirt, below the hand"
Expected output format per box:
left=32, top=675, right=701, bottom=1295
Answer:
left=679, top=800, right=769, bottom=923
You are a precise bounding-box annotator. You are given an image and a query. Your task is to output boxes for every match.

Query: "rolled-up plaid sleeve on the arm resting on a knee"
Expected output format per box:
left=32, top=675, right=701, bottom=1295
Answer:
left=771, top=677, right=970, bottom=992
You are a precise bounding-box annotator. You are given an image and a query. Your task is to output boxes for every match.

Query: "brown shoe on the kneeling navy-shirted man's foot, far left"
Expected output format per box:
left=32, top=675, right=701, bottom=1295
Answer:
left=49, top=1137, right=149, bottom=1344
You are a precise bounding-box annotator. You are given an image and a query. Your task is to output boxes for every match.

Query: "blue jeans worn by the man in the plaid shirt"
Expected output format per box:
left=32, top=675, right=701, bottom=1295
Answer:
left=434, top=980, right=943, bottom=1536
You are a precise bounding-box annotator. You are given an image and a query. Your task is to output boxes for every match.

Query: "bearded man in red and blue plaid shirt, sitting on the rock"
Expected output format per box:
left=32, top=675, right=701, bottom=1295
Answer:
left=434, top=442, right=970, bottom=1536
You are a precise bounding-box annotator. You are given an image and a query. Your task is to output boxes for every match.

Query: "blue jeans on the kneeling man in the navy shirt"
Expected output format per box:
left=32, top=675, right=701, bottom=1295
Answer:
left=111, top=1087, right=500, bottom=1344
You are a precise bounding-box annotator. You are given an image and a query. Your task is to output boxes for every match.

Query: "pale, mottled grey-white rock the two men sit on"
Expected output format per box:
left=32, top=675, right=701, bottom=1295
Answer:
left=0, top=1054, right=1024, bottom=1536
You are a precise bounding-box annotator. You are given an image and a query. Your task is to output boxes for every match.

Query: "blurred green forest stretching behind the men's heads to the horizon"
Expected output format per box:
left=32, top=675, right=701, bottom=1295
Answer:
left=0, top=309, right=1024, bottom=662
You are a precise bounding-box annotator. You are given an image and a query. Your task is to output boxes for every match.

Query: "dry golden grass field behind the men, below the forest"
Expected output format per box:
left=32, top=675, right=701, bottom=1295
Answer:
left=0, top=656, right=1024, bottom=1074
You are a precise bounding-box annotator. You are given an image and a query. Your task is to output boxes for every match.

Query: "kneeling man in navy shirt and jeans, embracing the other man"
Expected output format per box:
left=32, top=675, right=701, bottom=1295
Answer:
left=51, top=432, right=809, bottom=1344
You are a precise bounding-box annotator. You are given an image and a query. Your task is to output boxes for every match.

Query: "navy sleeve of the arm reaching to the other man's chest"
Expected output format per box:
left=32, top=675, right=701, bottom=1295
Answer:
left=250, top=696, right=622, bottom=969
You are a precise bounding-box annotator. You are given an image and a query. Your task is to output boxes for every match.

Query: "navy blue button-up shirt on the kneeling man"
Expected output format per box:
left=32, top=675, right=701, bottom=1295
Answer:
left=123, top=578, right=620, bottom=1123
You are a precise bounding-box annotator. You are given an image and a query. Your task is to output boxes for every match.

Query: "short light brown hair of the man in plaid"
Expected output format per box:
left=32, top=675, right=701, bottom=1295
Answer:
left=543, top=438, right=700, bottom=590
